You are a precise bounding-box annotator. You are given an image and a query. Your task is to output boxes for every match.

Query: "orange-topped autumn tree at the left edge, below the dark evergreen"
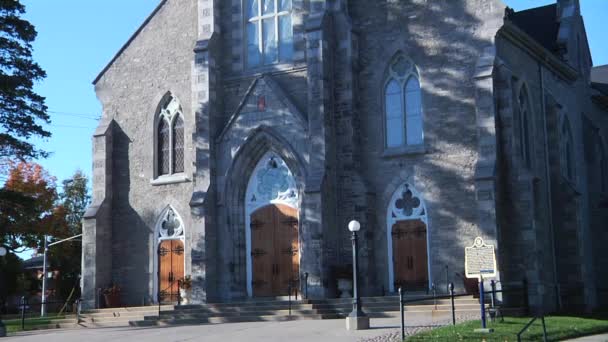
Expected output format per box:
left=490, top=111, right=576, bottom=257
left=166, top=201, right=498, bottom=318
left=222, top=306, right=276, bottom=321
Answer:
left=0, top=162, right=67, bottom=252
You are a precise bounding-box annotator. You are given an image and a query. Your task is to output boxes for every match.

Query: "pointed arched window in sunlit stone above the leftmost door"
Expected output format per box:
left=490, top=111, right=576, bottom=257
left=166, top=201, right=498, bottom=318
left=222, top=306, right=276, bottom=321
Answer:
left=155, top=94, right=184, bottom=176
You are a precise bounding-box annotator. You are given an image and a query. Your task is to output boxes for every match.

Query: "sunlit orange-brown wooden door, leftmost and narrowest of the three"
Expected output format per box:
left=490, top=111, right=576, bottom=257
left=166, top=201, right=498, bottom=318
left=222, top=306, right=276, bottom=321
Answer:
left=158, top=240, right=184, bottom=303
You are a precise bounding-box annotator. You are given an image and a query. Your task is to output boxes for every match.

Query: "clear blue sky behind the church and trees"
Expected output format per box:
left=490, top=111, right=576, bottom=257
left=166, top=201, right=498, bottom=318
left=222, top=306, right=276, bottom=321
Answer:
left=22, top=0, right=608, bottom=188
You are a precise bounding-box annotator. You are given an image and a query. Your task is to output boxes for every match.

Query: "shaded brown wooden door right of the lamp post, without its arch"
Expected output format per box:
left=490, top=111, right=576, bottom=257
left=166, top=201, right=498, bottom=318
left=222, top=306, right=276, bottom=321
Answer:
left=392, top=220, right=429, bottom=290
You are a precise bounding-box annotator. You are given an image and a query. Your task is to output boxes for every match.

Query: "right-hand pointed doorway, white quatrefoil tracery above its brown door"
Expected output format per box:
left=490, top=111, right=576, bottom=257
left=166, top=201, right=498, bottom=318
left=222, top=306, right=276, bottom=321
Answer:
left=386, top=183, right=430, bottom=292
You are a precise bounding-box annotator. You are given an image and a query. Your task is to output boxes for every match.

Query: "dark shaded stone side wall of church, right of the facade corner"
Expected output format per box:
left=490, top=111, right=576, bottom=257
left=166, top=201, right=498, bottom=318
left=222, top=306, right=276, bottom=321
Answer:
left=497, top=4, right=603, bottom=311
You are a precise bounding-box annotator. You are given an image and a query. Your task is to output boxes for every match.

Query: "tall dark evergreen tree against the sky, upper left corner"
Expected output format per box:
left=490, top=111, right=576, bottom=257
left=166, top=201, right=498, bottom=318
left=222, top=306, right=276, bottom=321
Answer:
left=0, top=0, right=50, bottom=160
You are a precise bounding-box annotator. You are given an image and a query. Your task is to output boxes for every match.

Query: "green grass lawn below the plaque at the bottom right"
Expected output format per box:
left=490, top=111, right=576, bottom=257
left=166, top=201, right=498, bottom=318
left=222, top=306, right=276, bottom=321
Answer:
left=406, top=316, right=608, bottom=342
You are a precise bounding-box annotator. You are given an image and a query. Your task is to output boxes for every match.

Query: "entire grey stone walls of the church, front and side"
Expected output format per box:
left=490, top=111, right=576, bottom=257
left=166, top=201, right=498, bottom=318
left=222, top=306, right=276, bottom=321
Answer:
left=83, top=0, right=608, bottom=309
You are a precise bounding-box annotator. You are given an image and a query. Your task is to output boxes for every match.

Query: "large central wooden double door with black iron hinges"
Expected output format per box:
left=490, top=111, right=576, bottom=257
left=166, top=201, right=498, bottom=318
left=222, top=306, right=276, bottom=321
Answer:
left=251, top=204, right=300, bottom=297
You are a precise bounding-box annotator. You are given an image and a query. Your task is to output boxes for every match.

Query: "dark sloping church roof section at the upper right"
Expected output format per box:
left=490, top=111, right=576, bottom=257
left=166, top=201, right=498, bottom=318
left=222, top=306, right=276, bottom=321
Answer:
left=509, top=4, right=559, bottom=52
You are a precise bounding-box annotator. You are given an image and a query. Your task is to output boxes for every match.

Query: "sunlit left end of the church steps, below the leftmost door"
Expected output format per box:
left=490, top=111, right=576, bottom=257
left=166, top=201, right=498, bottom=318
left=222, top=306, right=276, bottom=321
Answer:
left=78, top=305, right=174, bottom=328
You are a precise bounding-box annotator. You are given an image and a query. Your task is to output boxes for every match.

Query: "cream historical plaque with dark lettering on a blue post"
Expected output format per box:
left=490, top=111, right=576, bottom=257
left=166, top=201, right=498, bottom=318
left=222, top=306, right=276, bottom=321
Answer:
left=464, top=237, right=496, bottom=278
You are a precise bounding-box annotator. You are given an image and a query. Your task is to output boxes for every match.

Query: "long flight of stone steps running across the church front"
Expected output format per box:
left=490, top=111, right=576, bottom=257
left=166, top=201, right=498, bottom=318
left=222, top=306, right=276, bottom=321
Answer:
left=72, top=294, right=521, bottom=328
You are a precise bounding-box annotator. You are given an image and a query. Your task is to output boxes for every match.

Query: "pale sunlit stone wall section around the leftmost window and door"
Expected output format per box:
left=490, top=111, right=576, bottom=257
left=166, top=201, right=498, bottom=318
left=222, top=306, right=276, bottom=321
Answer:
left=89, top=0, right=197, bottom=305
